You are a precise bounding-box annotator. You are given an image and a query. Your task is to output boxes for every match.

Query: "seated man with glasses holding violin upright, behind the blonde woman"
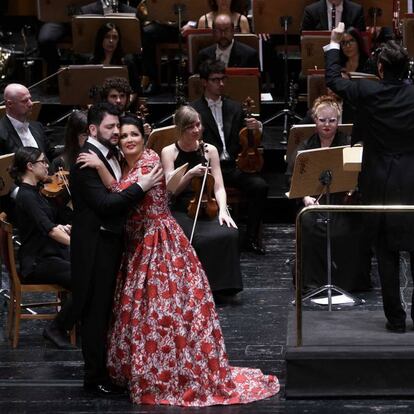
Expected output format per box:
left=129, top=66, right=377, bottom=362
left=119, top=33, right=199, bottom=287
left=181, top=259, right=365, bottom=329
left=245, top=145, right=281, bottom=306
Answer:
left=191, top=61, right=268, bottom=254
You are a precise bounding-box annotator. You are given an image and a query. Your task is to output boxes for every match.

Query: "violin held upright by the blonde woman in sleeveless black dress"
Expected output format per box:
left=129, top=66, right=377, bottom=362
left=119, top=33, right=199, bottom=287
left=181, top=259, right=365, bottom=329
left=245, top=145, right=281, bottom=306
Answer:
left=187, top=141, right=218, bottom=224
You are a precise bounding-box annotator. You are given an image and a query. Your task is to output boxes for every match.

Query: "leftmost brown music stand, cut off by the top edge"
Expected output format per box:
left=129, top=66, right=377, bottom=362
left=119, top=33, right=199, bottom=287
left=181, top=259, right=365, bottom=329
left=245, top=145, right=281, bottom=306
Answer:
left=37, top=0, right=91, bottom=23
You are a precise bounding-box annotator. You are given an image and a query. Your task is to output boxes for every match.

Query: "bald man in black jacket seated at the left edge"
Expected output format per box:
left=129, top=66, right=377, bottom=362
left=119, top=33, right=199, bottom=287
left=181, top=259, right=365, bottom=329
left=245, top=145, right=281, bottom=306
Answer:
left=0, top=83, right=55, bottom=160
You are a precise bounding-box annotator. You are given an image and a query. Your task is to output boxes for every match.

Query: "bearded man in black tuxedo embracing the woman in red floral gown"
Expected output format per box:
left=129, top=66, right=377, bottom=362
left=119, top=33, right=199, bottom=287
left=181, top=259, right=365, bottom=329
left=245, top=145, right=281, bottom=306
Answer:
left=70, top=103, right=162, bottom=396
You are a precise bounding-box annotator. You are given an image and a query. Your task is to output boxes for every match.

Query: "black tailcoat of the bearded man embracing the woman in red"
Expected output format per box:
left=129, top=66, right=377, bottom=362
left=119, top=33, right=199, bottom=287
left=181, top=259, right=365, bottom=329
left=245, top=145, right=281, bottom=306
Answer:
left=70, top=142, right=144, bottom=312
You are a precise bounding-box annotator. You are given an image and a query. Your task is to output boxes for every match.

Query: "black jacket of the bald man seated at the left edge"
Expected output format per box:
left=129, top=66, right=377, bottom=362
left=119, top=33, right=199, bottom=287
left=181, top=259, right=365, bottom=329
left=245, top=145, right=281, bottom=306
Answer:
left=0, top=116, right=55, bottom=160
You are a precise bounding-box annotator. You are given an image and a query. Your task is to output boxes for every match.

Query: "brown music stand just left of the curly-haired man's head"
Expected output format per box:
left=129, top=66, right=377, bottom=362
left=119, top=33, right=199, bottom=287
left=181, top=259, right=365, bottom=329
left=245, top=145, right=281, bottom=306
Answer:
left=58, top=65, right=128, bottom=106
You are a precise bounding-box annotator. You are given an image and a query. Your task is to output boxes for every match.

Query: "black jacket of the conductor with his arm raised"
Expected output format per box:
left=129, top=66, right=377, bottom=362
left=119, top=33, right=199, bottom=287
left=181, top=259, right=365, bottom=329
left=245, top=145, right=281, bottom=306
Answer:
left=325, top=50, right=414, bottom=251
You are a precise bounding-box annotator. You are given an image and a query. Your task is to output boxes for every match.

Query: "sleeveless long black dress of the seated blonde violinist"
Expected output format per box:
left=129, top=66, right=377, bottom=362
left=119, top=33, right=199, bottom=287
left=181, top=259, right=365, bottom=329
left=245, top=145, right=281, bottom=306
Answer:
left=172, top=144, right=243, bottom=294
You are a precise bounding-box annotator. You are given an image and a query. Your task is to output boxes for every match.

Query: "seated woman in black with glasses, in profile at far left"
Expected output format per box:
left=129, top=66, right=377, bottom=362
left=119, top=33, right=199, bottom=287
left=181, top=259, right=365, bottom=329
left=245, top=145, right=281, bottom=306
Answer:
left=10, top=147, right=75, bottom=349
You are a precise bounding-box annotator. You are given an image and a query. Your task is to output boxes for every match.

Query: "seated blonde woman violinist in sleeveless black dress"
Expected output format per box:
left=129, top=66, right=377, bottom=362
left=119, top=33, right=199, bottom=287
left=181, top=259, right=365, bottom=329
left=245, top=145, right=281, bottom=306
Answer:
left=161, top=106, right=243, bottom=301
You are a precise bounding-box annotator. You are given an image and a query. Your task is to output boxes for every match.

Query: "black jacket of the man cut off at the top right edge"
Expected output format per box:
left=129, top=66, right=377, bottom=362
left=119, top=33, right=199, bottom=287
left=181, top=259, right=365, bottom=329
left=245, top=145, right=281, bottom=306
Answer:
left=302, top=0, right=366, bottom=32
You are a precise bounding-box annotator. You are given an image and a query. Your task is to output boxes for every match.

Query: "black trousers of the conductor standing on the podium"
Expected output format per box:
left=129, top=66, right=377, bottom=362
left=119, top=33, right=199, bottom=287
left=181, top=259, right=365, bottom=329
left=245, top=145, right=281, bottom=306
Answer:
left=376, top=232, right=414, bottom=325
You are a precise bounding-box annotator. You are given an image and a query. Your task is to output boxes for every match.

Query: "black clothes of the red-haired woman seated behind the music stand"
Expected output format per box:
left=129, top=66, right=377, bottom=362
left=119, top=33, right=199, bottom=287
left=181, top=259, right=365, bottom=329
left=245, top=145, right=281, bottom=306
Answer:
left=288, top=132, right=371, bottom=291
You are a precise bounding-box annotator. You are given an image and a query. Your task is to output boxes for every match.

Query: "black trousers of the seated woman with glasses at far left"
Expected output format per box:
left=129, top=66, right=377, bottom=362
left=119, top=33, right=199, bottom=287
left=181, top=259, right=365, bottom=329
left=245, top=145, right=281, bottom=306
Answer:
left=24, top=256, right=76, bottom=331
